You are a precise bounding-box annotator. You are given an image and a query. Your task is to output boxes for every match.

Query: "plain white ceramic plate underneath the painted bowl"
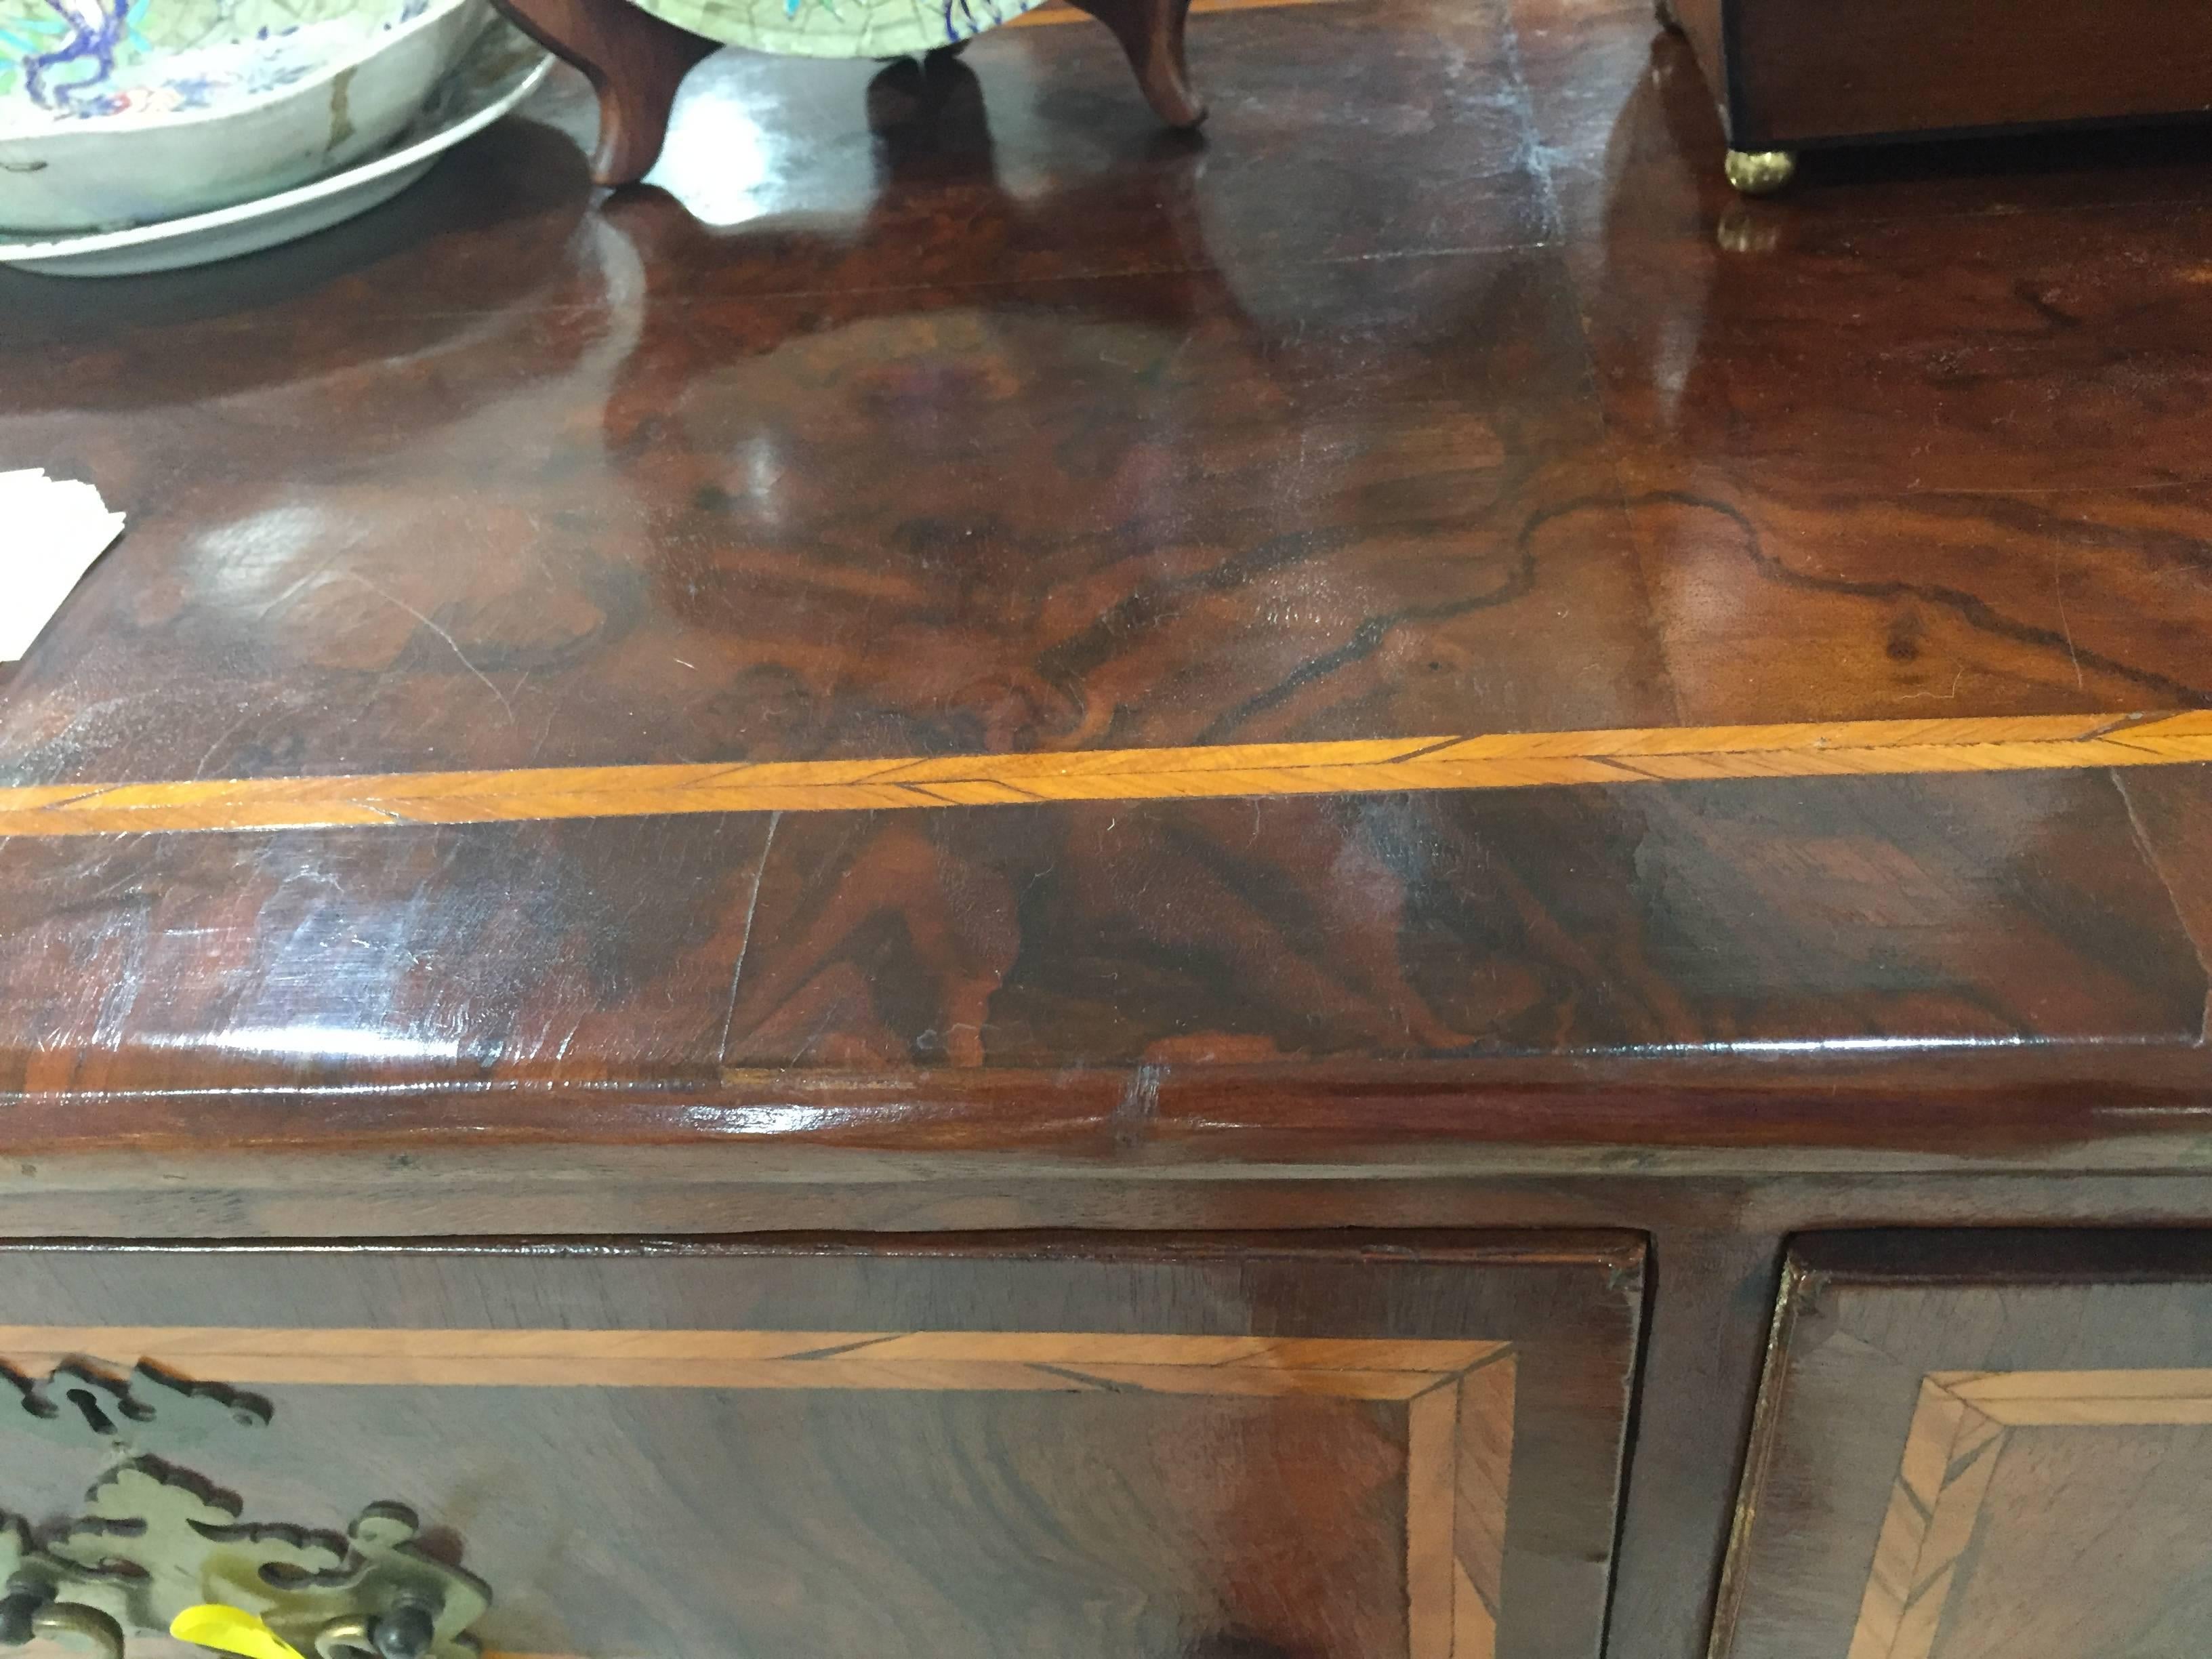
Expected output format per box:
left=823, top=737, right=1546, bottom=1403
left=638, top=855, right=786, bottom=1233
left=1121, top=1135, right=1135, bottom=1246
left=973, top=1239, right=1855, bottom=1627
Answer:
left=0, top=22, right=553, bottom=276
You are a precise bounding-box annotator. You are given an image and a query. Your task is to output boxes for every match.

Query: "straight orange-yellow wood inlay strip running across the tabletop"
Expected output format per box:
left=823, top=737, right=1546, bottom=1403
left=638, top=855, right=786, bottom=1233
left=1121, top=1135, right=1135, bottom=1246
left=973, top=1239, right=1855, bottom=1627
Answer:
left=0, top=712, right=2212, bottom=836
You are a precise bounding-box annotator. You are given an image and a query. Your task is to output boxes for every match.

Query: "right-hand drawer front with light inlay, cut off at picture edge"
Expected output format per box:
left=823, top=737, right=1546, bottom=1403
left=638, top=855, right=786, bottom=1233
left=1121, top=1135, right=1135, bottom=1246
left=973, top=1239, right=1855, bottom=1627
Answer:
left=1715, top=1234, right=2212, bottom=1659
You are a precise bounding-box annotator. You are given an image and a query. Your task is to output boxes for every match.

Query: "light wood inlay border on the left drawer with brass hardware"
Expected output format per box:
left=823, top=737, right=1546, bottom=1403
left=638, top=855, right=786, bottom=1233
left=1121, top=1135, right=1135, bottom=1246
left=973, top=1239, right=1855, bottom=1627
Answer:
left=0, top=1325, right=1515, bottom=1659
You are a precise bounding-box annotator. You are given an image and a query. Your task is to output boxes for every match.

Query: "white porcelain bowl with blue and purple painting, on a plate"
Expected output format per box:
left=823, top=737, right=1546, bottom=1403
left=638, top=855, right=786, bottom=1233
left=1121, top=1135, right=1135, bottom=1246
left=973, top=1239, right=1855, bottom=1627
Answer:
left=0, top=0, right=491, bottom=230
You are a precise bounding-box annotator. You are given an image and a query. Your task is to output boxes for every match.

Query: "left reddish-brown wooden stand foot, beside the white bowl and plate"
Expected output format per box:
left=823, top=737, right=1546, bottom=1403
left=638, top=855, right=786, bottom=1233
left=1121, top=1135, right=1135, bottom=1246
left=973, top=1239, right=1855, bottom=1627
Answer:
left=495, top=0, right=721, bottom=184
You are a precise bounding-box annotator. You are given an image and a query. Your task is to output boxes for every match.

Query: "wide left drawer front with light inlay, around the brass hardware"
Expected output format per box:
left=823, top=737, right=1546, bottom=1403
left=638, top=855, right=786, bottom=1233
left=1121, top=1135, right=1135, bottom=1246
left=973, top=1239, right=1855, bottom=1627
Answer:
left=0, top=1237, right=1641, bottom=1659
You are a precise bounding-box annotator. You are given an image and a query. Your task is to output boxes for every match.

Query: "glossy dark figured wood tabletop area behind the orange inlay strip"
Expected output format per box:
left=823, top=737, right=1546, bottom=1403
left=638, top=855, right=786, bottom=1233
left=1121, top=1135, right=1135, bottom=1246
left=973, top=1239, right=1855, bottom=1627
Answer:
left=17, top=0, right=2212, bottom=814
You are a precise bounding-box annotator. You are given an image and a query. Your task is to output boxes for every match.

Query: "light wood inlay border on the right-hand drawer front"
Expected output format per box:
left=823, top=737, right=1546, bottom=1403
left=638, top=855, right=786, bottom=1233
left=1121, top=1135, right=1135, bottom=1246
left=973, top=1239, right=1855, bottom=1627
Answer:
left=1849, top=1372, right=2212, bottom=1659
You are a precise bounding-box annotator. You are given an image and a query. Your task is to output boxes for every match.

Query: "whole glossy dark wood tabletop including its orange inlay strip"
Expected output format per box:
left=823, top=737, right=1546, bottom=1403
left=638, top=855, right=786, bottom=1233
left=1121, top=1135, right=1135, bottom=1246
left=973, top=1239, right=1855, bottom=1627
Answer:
left=0, top=0, right=2212, bottom=1157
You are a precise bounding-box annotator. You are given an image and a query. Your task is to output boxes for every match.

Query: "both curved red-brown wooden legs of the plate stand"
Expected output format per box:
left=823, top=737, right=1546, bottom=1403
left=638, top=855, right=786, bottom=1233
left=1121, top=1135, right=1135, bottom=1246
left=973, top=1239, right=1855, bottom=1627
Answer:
left=497, top=0, right=1206, bottom=184
